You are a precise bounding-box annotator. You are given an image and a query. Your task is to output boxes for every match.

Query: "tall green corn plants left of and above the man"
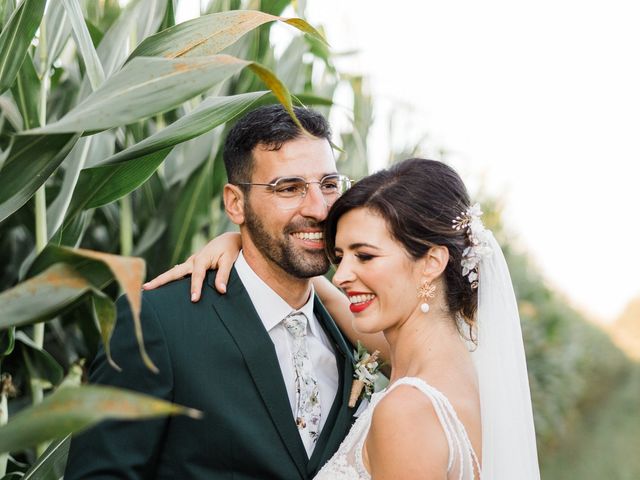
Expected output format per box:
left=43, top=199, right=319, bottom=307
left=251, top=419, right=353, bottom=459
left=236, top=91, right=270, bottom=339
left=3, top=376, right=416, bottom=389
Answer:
left=0, top=0, right=338, bottom=472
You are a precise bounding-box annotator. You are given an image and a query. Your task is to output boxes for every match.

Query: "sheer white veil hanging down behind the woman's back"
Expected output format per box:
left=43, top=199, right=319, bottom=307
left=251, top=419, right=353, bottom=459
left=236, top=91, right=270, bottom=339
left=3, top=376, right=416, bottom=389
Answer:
left=471, top=230, right=540, bottom=480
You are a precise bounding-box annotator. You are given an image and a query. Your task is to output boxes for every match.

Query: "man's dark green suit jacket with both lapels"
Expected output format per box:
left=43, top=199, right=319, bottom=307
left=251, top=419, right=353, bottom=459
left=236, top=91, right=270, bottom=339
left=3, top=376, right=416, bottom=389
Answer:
left=65, top=270, right=355, bottom=480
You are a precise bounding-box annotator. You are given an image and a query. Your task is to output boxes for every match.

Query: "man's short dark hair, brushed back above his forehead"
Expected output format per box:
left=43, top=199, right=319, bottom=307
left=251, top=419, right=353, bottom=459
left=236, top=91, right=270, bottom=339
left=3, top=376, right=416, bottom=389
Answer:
left=222, top=104, right=331, bottom=183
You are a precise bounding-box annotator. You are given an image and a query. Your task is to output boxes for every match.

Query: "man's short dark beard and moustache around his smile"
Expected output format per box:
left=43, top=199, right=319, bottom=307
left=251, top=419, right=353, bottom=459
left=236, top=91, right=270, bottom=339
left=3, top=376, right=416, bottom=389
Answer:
left=245, top=199, right=329, bottom=278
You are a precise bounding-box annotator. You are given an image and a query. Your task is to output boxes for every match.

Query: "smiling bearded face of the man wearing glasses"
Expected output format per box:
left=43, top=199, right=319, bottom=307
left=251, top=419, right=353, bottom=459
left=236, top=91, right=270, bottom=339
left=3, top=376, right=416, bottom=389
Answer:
left=243, top=137, right=336, bottom=278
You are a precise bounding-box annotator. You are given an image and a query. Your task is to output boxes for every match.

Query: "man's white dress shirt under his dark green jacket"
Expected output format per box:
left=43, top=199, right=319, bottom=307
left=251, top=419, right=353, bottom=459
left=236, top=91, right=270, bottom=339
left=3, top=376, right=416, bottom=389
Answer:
left=235, top=252, right=339, bottom=456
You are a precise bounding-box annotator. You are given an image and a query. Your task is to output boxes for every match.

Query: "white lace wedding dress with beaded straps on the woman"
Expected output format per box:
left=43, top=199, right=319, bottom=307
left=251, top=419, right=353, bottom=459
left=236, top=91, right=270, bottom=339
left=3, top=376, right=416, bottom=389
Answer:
left=314, top=377, right=480, bottom=480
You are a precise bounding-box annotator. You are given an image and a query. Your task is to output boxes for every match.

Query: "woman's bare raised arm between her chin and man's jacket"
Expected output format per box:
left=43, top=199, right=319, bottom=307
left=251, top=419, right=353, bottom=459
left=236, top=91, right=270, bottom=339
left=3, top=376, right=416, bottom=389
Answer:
left=312, top=276, right=390, bottom=361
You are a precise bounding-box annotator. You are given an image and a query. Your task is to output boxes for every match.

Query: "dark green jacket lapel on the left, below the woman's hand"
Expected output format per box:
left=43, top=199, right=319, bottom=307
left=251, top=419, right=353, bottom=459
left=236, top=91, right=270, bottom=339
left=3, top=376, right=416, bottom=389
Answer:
left=210, top=268, right=308, bottom=477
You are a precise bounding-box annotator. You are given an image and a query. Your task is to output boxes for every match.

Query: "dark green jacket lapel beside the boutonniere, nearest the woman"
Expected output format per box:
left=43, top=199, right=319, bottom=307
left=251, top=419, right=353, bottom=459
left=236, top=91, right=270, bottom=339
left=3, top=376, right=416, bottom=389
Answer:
left=307, top=297, right=355, bottom=476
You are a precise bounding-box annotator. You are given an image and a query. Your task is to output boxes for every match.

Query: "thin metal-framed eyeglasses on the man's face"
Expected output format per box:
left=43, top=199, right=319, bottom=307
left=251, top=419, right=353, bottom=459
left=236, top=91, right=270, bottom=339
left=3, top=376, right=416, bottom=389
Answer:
left=236, top=174, right=351, bottom=210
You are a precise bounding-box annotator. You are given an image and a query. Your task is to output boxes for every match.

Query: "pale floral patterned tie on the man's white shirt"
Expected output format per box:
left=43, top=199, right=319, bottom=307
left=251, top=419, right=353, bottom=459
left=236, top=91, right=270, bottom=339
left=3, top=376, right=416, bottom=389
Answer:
left=282, top=312, right=322, bottom=454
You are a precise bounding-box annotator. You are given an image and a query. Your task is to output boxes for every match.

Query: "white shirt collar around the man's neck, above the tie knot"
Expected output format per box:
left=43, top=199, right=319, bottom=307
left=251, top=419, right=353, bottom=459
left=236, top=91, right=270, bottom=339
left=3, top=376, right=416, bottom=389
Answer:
left=235, top=251, right=318, bottom=336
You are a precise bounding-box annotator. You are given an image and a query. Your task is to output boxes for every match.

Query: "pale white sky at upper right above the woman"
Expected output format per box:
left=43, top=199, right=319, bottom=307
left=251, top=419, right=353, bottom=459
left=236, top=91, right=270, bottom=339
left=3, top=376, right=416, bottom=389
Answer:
left=178, top=0, right=640, bottom=321
